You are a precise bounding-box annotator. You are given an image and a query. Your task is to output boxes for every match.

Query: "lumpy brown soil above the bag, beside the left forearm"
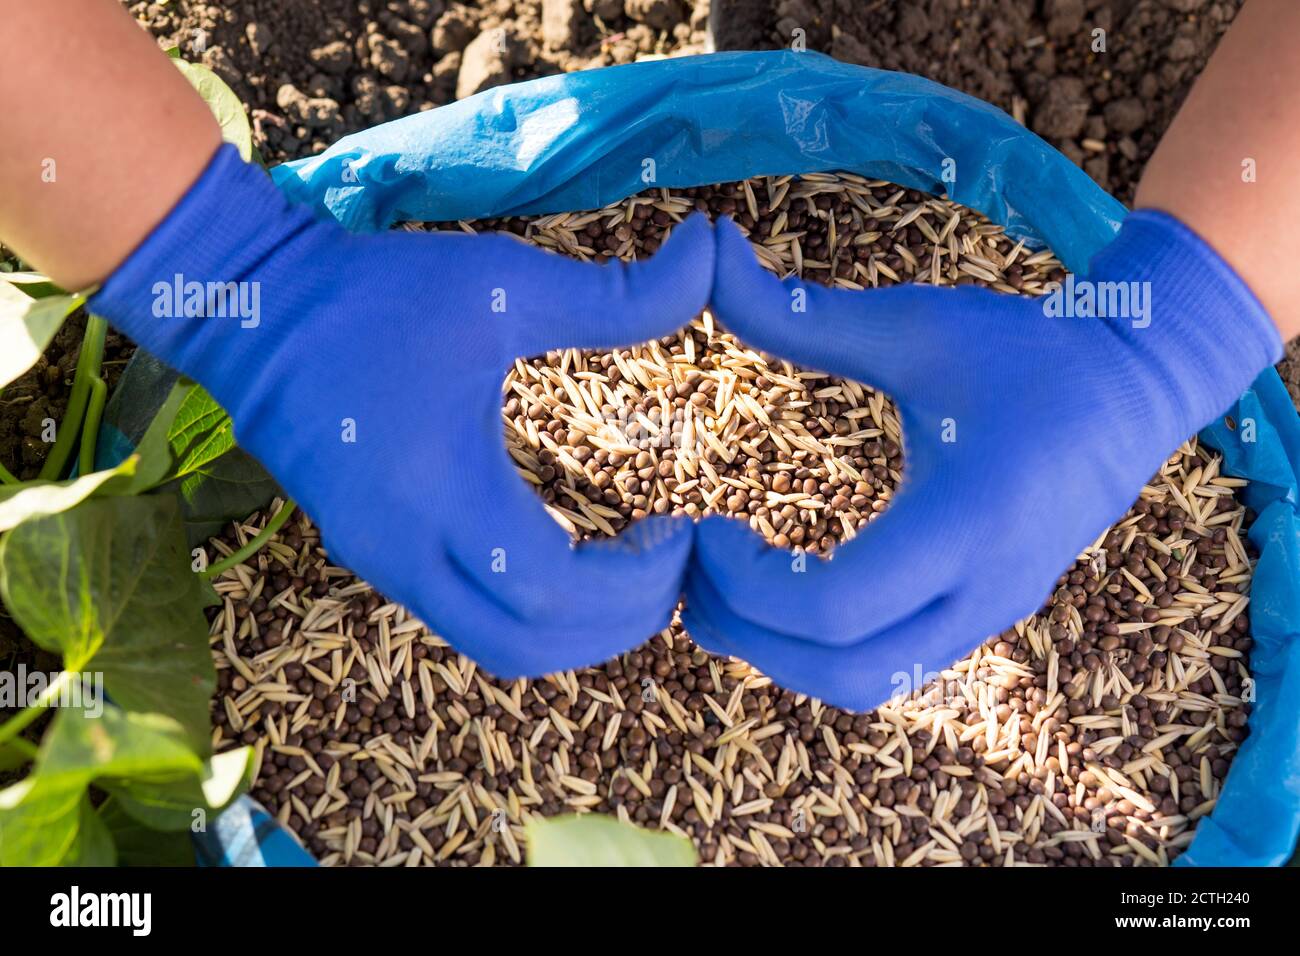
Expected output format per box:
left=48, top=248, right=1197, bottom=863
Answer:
left=127, top=0, right=709, bottom=163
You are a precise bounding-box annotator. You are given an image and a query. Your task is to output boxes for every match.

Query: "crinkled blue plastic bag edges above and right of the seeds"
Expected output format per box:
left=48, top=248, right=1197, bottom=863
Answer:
left=263, top=51, right=1300, bottom=866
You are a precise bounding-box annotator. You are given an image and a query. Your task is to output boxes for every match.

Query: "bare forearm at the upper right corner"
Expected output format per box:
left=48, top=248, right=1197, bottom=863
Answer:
left=1138, top=0, right=1300, bottom=339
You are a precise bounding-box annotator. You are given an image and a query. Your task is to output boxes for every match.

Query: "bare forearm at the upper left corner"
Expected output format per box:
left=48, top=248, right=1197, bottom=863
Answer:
left=0, top=0, right=221, bottom=289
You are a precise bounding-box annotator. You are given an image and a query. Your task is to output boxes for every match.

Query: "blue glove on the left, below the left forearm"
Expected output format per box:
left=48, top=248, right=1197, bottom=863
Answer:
left=90, top=146, right=715, bottom=676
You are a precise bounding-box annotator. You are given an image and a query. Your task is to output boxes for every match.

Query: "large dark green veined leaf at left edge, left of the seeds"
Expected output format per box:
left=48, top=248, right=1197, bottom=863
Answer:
left=0, top=496, right=216, bottom=753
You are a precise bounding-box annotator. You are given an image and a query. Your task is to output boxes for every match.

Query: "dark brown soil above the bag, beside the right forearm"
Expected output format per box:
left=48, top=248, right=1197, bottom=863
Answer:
left=715, top=0, right=1242, bottom=202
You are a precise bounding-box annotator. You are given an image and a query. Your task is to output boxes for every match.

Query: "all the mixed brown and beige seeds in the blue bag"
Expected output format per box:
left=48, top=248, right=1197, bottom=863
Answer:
left=212, top=176, right=1252, bottom=866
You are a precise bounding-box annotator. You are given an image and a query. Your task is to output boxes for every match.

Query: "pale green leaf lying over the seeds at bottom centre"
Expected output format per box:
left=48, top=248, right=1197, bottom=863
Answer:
left=524, top=813, right=696, bottom=866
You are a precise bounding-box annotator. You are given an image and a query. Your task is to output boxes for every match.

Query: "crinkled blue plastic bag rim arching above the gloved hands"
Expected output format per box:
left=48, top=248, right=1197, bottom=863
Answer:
left=272, top=51, right=1123, bottom=269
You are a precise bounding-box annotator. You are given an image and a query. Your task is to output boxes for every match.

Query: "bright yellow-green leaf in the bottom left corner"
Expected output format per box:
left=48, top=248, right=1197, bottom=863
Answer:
left=0, top=706, right=204, bottom=866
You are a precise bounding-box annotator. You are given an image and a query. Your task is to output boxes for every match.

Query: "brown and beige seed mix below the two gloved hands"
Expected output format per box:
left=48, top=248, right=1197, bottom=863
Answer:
left=212, top=444, right=1251, bottom=866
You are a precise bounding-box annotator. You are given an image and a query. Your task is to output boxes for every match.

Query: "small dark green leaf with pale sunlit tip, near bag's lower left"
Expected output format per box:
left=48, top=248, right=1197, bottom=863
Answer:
left=103, top=747, right=254, bottom=831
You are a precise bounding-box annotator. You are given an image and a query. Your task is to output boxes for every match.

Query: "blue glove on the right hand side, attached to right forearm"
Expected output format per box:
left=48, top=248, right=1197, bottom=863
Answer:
left=685, top=211, right=1282, bottom=709
